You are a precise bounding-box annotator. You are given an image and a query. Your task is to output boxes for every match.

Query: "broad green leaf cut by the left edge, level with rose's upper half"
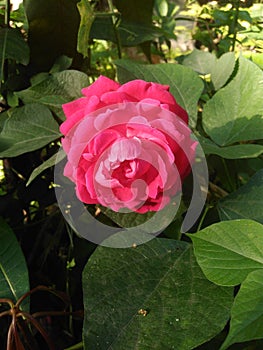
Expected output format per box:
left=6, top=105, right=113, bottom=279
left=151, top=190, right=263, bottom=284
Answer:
left=0, top=103, right=61, bottom=157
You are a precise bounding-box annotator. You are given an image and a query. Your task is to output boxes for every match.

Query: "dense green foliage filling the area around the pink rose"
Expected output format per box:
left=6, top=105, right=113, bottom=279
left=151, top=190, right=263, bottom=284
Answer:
left=0, top=0, right=263, bottom=350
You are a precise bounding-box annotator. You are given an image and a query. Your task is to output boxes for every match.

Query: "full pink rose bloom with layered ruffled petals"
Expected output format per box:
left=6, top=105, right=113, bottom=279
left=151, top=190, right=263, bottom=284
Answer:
left=60, top=76, right=197, bottom=213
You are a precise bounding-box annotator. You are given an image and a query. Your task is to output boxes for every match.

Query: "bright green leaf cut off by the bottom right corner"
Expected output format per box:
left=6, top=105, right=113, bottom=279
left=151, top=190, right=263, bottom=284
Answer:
left=220, top=270, right=263, bottom=350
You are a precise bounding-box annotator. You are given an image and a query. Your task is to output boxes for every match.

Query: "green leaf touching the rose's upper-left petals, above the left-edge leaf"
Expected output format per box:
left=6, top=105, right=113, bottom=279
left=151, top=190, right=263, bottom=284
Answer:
left=16, top=70, right=89, bottom=119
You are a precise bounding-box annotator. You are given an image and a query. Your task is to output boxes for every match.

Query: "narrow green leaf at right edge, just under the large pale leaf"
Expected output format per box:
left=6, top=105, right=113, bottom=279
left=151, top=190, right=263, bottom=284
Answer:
left=197, top=135, right=263, bottom=159
